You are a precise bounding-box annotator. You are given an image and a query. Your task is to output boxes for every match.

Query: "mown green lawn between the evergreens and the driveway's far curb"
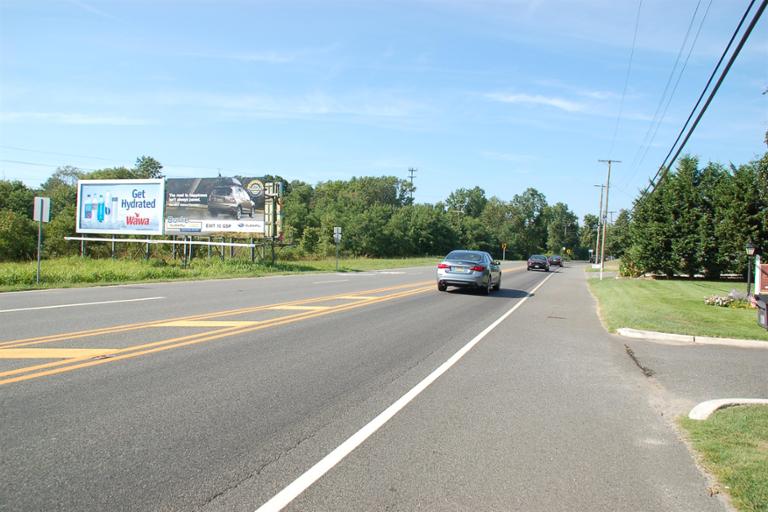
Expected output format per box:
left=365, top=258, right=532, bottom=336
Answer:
left=589, top=279, right=768, bottom=341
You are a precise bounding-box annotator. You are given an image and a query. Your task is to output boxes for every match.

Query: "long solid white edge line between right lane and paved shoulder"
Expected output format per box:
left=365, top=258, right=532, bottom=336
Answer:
left=256, top=274, right=554, bottom=512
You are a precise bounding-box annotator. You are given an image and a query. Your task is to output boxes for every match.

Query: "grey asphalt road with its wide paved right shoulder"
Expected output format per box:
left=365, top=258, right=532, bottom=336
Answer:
left=0, top=263, right=748, bottom=511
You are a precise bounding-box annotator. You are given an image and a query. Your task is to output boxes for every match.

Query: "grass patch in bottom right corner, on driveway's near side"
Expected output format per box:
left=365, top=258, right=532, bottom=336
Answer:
left=680, top=406, right=768, bottom=512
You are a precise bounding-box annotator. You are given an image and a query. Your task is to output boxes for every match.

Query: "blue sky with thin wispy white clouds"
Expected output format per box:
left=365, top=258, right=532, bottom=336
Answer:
left=0, top=0, right=768, bottom=218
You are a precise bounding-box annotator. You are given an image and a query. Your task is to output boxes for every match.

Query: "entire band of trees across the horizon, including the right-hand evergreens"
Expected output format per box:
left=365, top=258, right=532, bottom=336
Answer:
left=0, top=153, right=768, bottom=272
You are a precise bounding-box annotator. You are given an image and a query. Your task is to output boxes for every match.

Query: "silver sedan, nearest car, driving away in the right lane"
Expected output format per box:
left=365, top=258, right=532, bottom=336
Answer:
left=437, top=250, right=501, bottom=295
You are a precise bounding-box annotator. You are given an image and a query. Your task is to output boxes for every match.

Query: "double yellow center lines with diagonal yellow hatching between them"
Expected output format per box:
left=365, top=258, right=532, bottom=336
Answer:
left=0, top=281, right=434, bottom=385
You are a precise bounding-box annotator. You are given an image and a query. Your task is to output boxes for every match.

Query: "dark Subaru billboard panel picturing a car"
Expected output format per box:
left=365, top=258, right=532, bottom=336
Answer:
left=165, top=177, right=266, bottom=237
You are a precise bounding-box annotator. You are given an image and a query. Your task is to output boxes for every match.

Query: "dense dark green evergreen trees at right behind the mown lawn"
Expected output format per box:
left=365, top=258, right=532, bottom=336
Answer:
left=613, top=153, right=768, bottom=279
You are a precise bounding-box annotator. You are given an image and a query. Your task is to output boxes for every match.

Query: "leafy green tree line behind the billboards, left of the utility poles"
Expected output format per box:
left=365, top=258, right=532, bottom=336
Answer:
left=0, top=156, right=585, bottom=261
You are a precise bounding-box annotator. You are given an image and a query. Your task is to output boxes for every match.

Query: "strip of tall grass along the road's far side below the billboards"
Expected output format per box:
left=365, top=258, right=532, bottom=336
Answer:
left=0, top=257, right=439, bottom=291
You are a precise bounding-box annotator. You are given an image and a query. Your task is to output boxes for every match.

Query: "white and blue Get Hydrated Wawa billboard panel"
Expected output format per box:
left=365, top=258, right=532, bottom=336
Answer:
left=75, top=179, right=165, bottom=235
